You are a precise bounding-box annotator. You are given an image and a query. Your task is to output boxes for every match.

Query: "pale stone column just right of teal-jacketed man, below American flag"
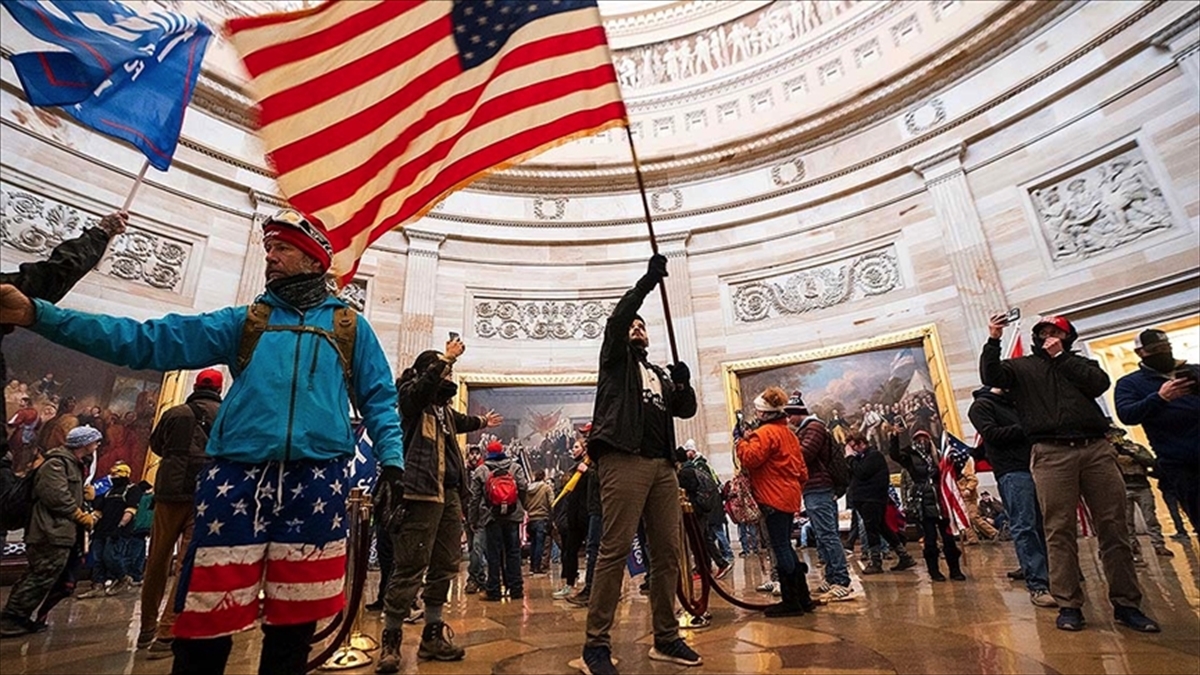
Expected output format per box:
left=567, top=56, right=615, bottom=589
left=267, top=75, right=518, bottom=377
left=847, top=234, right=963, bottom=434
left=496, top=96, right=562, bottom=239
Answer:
left=396, top=227, right=445, bottom=370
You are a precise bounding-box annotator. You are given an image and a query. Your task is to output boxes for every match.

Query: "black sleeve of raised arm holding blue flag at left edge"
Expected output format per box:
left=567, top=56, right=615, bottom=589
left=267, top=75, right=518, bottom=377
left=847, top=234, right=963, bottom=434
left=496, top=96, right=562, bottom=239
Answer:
left=0, top=227, right=109, bottom=425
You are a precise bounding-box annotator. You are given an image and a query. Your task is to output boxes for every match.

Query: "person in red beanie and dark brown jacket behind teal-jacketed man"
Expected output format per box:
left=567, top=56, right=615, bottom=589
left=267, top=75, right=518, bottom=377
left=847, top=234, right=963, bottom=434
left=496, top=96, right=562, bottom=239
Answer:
left=137, top=369, right=224, bottom=658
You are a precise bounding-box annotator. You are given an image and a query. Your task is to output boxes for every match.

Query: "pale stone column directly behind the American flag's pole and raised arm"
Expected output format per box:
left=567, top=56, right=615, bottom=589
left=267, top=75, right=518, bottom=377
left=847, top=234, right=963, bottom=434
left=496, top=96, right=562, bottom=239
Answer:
left=658, top=232, right=710, bottom=455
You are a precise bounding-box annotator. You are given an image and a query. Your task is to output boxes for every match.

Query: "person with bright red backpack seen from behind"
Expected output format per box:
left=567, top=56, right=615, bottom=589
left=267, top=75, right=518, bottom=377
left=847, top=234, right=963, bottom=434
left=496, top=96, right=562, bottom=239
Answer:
left=467, top=441, right=529, bottom=602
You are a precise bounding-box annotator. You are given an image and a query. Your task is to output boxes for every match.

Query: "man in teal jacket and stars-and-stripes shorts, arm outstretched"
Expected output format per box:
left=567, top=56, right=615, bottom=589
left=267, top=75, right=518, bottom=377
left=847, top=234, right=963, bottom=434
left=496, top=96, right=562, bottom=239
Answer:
left=0, top=209, right=403, bottom=674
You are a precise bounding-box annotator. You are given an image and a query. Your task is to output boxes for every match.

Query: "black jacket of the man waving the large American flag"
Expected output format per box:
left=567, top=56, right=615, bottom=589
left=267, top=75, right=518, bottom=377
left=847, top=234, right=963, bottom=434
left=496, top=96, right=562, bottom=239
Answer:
left=588, top=275, right=696, bottom=461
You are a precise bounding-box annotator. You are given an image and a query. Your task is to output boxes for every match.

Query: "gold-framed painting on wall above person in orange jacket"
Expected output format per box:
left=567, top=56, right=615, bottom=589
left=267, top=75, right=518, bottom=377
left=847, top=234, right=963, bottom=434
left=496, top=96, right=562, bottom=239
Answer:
left=724, top=324, right=961, bottom=450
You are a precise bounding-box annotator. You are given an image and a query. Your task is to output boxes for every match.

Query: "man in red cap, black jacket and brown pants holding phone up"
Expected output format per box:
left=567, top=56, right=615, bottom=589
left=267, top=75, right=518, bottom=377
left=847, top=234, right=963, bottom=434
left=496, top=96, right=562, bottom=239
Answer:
left=979, top=315, right=1159, bottom=633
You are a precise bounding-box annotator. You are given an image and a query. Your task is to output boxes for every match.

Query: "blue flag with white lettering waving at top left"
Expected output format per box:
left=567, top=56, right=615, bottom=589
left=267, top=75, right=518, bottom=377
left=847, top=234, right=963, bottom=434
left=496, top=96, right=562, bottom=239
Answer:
left=4, top=0, right=212, bottom=171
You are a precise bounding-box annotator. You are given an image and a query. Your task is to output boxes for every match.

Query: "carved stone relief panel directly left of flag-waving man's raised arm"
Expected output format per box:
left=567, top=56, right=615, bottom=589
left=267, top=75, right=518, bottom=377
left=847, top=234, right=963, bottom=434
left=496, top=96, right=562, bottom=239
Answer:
left=474, top=299, right=617, bottom=340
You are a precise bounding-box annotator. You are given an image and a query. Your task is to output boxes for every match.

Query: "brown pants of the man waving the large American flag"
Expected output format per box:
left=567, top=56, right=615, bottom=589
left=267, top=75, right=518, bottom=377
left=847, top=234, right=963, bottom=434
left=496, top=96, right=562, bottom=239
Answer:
left=587, top=450, right=683, bottom=647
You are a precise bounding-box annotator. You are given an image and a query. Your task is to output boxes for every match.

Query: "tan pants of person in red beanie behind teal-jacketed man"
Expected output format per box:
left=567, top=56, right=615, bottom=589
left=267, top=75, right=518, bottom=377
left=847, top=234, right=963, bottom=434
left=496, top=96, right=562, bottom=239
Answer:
left=142, top=502, right=196, bottom=640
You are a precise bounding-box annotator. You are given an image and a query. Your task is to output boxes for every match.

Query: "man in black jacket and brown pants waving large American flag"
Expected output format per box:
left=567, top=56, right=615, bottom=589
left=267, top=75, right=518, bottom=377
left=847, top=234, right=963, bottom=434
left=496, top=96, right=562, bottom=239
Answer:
left=583, top=253, right=703, bottom=675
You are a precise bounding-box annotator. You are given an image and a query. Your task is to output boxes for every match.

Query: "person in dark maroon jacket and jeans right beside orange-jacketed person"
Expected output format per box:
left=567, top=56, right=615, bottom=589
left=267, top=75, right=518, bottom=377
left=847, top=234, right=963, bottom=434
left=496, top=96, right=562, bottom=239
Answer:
left=784, top=392, right=854, bottom=602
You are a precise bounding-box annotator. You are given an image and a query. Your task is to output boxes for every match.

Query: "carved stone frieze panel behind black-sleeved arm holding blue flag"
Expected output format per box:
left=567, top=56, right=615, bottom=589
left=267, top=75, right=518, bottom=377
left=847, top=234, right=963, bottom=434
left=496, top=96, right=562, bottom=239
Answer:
left=0, top=184, right=192, bottom=293
